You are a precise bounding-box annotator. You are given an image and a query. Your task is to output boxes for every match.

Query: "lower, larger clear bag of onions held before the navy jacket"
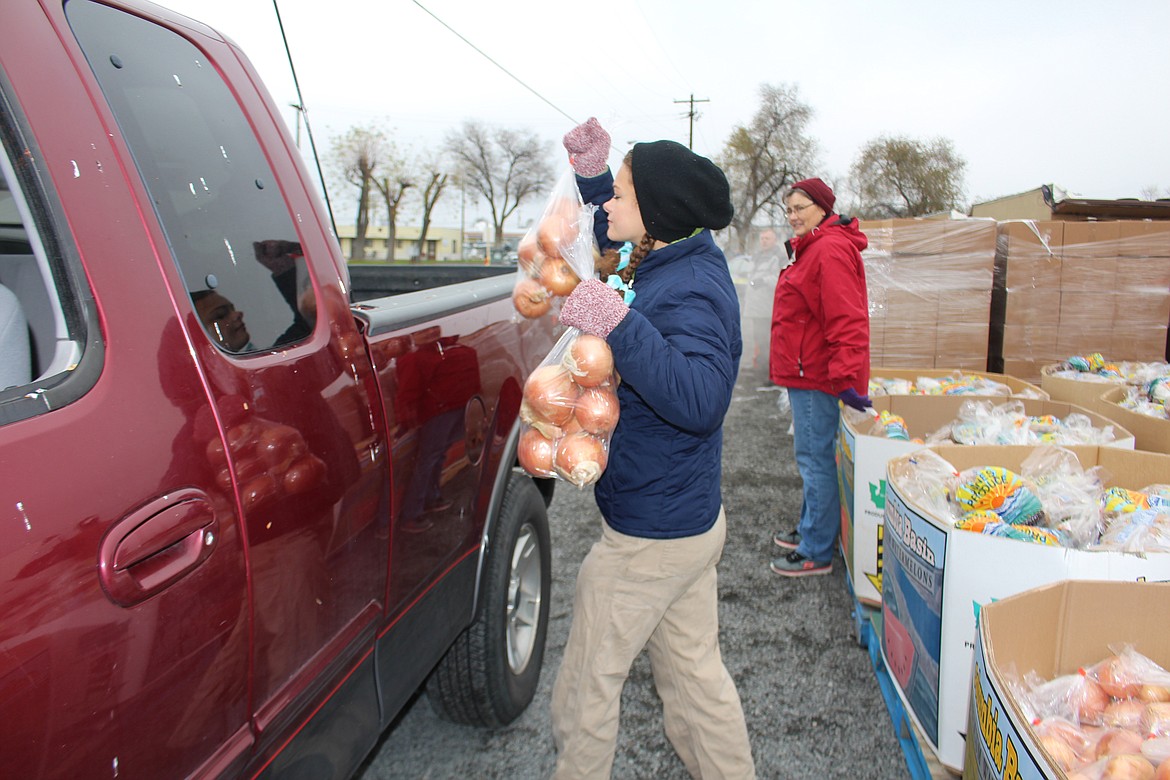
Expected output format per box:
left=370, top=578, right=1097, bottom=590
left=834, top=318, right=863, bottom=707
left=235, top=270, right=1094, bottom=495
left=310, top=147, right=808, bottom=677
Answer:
left=518, top=327, right=618, bottom=488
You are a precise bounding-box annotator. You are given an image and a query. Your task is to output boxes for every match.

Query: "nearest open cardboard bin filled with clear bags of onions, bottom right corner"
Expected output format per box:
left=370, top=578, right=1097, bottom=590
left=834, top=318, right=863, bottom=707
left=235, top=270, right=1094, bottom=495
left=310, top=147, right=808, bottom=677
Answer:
left=963, top=581, right=1170, bottom=780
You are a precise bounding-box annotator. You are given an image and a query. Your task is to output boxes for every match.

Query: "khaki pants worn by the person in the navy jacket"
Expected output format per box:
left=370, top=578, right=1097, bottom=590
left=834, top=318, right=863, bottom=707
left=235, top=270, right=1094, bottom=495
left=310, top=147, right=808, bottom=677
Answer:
left=552, top=510, right=756, bottom=780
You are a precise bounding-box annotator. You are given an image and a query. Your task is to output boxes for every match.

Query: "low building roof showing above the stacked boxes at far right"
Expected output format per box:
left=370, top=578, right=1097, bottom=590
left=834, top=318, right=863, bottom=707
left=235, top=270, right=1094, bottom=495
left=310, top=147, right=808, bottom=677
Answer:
left=971, top=185, right=1170, bottom=222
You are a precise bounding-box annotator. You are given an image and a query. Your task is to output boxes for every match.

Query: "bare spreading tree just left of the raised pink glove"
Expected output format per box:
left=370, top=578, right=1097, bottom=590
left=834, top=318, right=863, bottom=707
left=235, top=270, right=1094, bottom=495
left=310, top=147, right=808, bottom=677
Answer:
left=445, top=122, right=552, bottom=247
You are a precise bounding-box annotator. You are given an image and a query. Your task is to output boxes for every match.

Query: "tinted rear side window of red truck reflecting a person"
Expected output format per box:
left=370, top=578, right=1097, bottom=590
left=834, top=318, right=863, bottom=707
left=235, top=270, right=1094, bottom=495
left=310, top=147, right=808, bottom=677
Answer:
left=66, top=0, right=316, bottom=354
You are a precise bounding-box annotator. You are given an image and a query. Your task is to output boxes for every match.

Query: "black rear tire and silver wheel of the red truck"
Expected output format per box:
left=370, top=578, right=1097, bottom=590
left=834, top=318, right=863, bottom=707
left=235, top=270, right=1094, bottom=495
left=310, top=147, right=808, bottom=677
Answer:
left=427, top=472, right=552, bottom=727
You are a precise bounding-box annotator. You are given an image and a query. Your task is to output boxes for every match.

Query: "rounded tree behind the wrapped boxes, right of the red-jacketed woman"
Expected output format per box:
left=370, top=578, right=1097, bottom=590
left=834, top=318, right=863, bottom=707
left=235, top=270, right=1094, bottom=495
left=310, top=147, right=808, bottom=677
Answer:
left=851, top=136, right=966, bottom=219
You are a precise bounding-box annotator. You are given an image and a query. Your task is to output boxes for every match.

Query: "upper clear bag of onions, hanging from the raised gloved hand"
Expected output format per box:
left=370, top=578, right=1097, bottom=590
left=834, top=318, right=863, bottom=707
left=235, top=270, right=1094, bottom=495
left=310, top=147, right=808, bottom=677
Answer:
left=512, top=168, right=598, bottom=319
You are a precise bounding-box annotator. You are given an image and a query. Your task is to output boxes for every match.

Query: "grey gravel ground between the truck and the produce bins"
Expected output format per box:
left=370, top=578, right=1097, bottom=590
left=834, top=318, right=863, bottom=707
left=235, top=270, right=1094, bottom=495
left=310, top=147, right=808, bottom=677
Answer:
left=358, top=375, right=909, bottom=780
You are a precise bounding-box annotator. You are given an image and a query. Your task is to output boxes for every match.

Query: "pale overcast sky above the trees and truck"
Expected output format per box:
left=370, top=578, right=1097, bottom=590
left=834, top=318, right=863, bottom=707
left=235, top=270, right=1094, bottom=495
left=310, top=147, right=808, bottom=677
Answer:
left=161, top=0, right=1170, bottom=219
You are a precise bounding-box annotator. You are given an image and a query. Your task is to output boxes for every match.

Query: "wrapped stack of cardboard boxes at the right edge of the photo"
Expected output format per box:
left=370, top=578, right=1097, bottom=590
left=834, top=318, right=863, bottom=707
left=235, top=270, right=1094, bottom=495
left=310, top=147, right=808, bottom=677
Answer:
left=987, top=220, right=1170, bottom=381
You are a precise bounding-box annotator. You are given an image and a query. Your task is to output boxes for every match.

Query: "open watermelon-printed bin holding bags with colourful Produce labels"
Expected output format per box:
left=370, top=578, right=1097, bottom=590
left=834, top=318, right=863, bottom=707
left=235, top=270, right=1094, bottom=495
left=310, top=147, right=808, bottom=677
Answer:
left=880, top=446, right=1170, bottom=772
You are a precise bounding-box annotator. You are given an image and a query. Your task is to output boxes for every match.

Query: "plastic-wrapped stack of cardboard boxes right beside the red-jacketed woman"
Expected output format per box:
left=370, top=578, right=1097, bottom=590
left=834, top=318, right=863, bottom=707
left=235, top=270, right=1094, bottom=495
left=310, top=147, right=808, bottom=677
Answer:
left=860, top=220, right=996, bottom=371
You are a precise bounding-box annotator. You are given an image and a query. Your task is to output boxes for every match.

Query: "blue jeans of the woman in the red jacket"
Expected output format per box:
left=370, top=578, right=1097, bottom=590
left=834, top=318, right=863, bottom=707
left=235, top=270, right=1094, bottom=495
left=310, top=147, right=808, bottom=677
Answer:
left=789, top=387, right=841, bottom=564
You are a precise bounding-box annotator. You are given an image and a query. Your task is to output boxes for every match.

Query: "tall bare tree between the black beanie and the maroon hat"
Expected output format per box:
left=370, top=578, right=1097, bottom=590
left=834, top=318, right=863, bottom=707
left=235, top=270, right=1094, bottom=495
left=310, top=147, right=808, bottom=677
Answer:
left=720, top=84, right=818, bottom=253
